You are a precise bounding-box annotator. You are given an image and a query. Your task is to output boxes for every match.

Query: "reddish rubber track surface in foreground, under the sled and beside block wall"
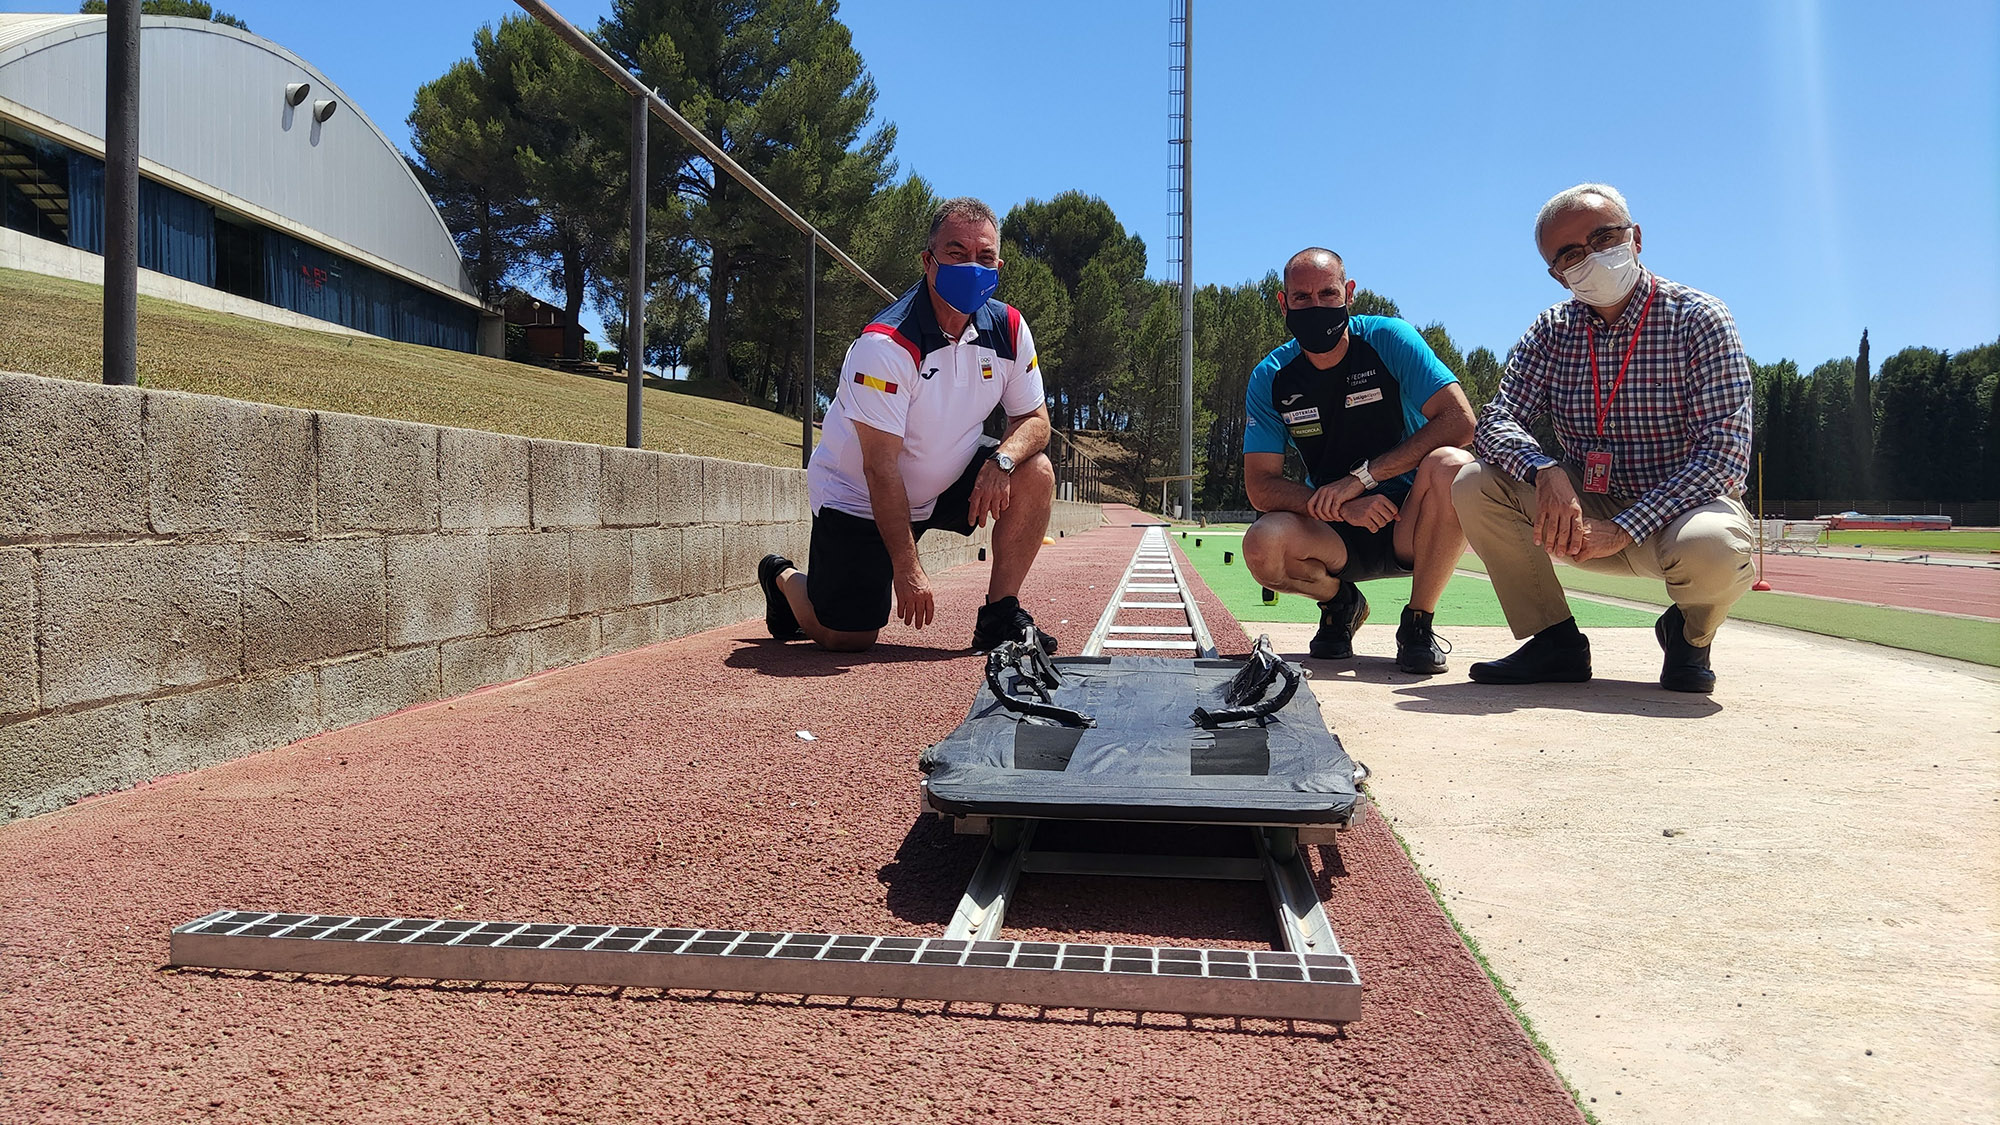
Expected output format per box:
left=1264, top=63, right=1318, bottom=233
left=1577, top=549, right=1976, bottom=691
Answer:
left=0, top=508, right=1580, bottom=1123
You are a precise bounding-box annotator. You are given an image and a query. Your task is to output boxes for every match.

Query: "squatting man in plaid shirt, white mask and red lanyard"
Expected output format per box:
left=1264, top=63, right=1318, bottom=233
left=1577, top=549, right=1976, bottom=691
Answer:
left=1452, top=184, right=1754, bottom=693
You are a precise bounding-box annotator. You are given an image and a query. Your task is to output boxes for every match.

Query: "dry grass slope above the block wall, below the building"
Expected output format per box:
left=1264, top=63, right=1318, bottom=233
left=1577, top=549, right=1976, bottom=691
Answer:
left=0, top=270, right=800, bottom=468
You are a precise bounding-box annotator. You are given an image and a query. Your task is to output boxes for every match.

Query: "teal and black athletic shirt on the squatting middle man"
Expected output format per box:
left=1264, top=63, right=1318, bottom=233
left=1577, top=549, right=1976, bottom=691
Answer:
left=1244, top=316, right=1458, bottom=492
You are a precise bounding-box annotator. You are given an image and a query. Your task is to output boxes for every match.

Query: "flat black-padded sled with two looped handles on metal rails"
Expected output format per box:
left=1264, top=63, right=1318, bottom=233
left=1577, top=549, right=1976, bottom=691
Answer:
left=918, top=637, right=1366, bottom=1021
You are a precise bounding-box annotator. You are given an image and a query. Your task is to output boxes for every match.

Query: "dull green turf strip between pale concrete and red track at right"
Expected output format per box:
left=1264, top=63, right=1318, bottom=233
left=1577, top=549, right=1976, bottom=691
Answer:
left=1456, top=554, right=2000, bottom=667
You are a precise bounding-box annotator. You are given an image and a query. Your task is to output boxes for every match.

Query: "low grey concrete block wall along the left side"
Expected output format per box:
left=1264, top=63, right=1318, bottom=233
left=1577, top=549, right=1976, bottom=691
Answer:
left=0, top=372, right=1102, bottom=821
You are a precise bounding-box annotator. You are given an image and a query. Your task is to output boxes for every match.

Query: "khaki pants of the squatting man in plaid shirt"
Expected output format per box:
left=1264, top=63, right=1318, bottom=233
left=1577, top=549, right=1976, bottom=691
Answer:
left=1452, top=460, right=1756, bottom=645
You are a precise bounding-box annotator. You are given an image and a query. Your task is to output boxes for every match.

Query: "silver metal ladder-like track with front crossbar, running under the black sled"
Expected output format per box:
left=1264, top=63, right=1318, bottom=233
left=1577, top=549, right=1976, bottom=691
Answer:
left=170, top=528, right=1360, bottom=1023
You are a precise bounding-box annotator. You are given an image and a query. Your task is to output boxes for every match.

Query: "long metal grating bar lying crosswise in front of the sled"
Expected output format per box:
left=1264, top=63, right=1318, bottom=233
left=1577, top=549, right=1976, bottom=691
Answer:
left=170, top=911, right=1360, bottom=1021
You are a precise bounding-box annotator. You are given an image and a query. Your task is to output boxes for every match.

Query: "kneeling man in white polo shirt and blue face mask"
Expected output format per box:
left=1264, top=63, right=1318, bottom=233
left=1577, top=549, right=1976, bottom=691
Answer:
left=758, top=198, right=1056, bottom=653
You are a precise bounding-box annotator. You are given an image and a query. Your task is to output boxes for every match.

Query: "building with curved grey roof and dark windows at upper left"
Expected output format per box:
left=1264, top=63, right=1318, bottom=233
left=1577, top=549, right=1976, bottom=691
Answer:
left=0, top=14, right=492, bottom=350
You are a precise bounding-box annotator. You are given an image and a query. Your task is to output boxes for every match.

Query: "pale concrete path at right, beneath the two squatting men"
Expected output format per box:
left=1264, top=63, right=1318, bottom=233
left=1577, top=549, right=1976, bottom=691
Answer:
left=1250, top=607, right=2000, bottom=1125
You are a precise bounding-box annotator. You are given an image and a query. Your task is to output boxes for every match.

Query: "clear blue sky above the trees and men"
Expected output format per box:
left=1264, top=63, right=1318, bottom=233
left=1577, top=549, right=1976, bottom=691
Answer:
left=0, top=0, right=2000, bottom=368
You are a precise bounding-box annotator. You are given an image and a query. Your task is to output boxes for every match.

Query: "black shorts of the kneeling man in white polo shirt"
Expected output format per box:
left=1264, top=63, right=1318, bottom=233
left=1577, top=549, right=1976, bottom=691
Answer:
left=806, top=442, right=984, bottom=633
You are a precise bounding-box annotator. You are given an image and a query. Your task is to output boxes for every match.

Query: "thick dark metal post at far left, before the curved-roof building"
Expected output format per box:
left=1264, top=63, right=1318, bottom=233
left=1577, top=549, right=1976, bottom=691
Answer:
left=104, top=0, right=138, bottom=386
